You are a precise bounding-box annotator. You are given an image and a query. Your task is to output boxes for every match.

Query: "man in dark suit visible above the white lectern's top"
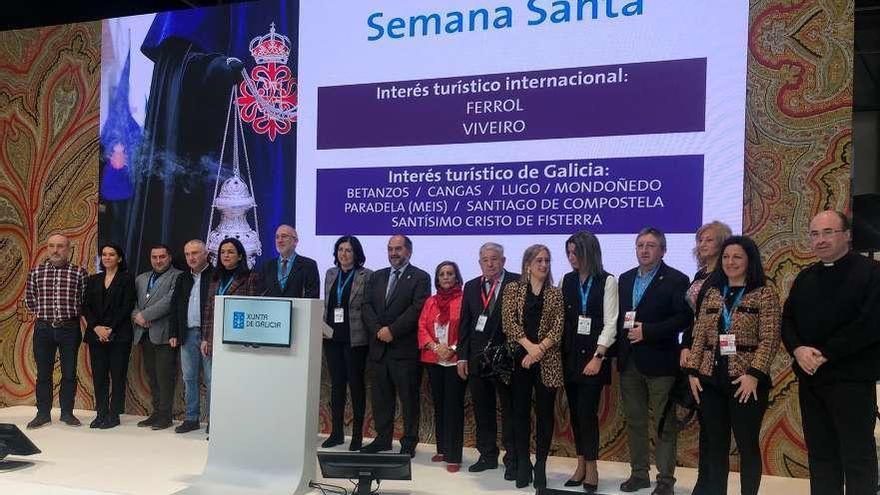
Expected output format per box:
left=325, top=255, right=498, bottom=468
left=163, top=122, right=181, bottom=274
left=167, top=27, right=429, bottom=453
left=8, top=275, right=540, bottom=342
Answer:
left=259, top=224, right=321, bottom=299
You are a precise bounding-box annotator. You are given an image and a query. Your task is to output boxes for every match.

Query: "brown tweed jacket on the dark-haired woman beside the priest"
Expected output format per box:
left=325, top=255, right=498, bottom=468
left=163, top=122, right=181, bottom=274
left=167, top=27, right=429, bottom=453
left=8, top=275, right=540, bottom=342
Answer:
left=686, top=286, right=781, bottom=381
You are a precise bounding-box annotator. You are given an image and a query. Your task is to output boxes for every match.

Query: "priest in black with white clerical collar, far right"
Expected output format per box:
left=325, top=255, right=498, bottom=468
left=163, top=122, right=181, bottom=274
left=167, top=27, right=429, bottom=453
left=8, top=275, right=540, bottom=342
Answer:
left=782, top=210, right=880, bottom=495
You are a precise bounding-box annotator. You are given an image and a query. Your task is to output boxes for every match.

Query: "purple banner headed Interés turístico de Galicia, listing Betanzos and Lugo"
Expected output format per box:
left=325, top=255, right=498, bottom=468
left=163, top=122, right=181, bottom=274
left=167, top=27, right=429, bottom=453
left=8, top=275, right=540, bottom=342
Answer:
left=316, top=155, right=703, bottom=235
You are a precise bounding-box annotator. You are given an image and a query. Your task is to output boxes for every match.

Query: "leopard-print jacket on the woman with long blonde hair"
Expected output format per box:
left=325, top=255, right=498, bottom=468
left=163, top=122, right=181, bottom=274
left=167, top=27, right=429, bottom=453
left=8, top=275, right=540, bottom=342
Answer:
left=501, top=281, right=565, bottom=387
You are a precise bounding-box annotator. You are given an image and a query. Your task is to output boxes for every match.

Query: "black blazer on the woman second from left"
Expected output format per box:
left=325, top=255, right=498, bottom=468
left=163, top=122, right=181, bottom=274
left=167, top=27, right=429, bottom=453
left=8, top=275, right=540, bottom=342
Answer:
left=83, top=271, right=137, bottom=343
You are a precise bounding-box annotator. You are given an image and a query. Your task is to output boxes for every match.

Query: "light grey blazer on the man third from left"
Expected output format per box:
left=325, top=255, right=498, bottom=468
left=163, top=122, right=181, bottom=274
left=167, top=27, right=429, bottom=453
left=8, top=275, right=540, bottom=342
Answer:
left=131, top=266, right=183, bottom=345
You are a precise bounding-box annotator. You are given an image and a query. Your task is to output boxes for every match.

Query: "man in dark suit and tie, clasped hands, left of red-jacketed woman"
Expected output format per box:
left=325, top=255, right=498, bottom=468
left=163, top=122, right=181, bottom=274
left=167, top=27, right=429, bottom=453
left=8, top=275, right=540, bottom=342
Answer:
left=361, top=235, right=431, bottom=457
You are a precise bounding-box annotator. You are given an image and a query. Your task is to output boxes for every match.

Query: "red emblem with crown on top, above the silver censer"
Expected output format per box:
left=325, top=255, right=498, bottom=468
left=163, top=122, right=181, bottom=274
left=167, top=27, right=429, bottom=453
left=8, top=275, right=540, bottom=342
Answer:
left=237, top=22, right=297, bottom=141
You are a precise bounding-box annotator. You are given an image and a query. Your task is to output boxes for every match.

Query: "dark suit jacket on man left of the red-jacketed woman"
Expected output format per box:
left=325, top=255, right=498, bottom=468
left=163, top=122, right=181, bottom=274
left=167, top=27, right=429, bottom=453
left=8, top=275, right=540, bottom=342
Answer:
left=363, top=265, right=431, bottom=361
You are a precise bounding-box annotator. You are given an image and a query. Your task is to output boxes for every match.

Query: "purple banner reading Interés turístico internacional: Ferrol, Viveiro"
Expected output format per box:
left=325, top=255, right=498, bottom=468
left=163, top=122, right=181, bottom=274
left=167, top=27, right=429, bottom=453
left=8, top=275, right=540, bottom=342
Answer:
left=317, top=58, right=706, bottom=149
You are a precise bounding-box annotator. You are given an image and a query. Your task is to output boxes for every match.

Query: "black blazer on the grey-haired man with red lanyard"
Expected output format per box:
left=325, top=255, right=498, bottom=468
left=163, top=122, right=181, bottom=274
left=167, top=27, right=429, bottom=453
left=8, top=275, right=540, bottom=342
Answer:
left=456, top=270, right=519, bottom=361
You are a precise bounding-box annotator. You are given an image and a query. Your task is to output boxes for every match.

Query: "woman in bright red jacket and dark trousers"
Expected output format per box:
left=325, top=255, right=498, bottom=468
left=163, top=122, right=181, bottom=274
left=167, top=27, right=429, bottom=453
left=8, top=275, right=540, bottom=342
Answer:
left=419, top=261, right=465, bottom=473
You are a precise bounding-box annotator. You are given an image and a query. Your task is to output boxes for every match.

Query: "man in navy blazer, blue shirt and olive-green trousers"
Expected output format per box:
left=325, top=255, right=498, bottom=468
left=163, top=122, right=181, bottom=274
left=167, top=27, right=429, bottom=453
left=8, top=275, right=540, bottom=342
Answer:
left=617, top=227, right=693, bottom=495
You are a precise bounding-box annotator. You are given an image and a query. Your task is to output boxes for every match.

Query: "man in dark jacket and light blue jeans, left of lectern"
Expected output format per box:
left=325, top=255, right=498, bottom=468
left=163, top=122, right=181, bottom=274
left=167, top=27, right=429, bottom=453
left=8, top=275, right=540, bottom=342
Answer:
left=169, top=239, right=214, bottom=433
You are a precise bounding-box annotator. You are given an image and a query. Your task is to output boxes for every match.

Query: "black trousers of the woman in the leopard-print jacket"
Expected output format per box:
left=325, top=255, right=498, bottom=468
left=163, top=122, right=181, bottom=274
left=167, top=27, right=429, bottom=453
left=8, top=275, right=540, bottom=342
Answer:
left=510, top=365, right=556, bottom=464
